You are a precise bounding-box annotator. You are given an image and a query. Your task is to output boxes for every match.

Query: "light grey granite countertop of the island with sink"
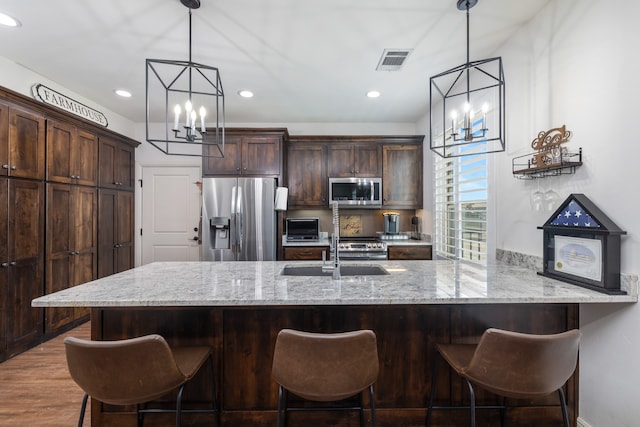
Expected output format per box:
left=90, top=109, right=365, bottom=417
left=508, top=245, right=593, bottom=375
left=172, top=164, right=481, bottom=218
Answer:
left=32, top=261, right=638, bottom=307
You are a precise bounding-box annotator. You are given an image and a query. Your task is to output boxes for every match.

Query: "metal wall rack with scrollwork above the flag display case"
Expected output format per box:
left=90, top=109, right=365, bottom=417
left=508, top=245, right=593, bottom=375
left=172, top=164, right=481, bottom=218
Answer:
left=512, top=125, right=582, bottom=179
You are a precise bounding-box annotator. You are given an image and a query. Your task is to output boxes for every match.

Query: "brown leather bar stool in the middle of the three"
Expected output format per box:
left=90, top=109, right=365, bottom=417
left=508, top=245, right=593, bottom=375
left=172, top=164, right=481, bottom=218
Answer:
left=271, top=329, right=379, bottom=427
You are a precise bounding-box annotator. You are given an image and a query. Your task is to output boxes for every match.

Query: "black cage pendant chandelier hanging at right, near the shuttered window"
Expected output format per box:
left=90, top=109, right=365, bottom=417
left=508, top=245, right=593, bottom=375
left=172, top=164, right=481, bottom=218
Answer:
left=429, top=0, right=505, bottom=157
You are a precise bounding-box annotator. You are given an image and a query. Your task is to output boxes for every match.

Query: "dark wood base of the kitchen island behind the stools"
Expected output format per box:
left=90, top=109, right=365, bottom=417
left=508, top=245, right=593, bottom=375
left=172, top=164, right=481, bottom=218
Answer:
left=91, top=303, right=578, bottom=427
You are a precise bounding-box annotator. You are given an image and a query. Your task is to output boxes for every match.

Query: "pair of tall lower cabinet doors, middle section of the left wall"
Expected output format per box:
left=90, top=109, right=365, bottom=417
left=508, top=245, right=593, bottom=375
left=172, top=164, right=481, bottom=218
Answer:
left=45, top=183, right=98, bottom=334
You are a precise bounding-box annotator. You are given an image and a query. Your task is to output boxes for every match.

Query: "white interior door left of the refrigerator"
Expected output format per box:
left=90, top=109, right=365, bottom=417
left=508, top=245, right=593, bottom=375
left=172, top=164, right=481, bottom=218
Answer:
left=141, top=167, right=201, bottom=264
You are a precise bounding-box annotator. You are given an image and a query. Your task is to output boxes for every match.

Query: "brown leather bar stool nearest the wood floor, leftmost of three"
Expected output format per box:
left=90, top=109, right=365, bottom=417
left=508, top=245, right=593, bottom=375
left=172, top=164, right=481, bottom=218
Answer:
left=64, top=334, right=220, bottom=427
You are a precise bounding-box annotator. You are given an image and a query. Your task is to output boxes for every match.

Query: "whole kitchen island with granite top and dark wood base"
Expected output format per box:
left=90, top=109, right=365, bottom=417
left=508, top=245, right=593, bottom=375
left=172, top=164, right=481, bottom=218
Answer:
left=33, top=261, right=638, bottom=426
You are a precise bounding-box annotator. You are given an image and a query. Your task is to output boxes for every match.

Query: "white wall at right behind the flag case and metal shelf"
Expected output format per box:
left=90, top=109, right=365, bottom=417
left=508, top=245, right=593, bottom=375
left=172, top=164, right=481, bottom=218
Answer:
left=495, top=0, right=640, bottom=427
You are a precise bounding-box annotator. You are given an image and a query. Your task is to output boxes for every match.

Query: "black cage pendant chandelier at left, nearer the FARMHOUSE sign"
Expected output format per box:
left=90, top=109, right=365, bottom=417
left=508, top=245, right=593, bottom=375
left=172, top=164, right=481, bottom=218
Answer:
left=146, top=0, right=224, bottom=157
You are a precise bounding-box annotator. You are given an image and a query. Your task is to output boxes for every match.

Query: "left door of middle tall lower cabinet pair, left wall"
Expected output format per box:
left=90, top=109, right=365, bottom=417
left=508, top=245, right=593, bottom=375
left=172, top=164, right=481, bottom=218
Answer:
left=45, top=183, right=75, bottom=333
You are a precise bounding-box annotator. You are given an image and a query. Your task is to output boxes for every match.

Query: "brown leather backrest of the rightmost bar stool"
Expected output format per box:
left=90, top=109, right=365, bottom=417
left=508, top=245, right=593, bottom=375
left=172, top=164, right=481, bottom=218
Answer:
left=464, top=328, right=580, bottom=398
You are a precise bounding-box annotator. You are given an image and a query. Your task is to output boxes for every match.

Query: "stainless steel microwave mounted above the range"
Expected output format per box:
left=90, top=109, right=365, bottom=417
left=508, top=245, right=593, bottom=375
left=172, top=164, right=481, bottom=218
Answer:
left=329, top=178, right=382, bottom=208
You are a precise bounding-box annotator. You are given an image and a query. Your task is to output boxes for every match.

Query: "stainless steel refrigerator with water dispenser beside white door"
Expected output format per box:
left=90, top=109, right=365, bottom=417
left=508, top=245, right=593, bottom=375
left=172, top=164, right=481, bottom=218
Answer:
left=201, top=178, right=276, bottom=261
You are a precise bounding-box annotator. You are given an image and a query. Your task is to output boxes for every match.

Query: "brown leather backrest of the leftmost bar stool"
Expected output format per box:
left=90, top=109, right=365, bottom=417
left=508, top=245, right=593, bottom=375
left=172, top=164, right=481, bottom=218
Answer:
left=64, top=334, right=185, bottom=405
